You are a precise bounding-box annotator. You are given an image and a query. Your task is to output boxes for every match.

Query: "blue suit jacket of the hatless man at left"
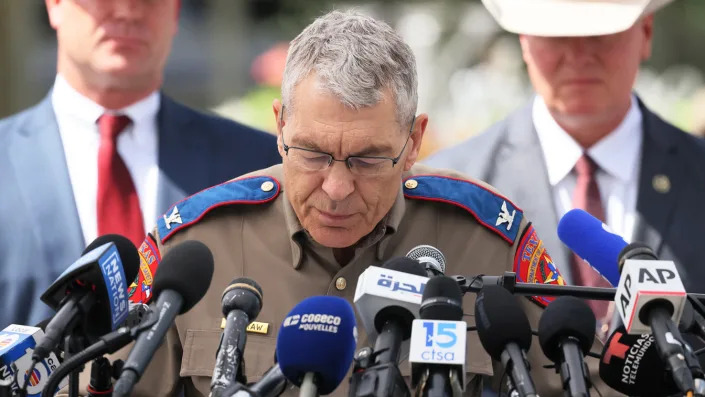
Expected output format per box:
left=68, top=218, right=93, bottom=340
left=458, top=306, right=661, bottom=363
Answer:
left=0, top=95, right=281, bottom=329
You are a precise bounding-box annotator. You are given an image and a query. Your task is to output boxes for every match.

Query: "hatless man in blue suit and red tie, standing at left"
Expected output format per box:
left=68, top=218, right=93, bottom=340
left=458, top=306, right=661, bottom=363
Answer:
left=0, top=0, right=281, bottom=329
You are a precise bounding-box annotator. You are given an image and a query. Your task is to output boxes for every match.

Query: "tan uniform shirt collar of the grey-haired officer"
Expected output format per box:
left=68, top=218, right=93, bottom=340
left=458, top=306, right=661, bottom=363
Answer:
left=282, top=178, right=406, bottom=269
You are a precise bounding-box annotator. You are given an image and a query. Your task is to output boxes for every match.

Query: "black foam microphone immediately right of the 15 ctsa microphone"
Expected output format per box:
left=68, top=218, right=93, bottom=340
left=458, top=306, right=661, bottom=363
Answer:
left=476, top=283, right=538, bottom=397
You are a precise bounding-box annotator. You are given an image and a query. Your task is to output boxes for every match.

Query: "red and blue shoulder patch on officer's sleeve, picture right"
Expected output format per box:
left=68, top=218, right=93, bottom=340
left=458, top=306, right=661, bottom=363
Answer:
left=514, top=224, right=565, bottom=307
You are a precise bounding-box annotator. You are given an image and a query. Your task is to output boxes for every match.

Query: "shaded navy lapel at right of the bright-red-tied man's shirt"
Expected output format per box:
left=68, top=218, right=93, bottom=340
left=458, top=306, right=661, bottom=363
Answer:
left=153, top=94, right=205, bottom=221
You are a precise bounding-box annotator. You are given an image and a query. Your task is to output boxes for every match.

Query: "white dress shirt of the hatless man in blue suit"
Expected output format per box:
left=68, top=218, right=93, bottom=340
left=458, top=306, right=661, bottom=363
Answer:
left=51, top=75, right=161, bottom=244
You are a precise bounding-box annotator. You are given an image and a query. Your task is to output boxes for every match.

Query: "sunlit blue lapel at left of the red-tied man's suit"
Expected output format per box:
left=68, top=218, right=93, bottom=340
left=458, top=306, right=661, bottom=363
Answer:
left=8, top=95, right=85, bottom=262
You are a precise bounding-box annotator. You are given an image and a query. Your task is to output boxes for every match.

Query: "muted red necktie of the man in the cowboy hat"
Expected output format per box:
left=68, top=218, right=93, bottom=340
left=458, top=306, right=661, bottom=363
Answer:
left=572, top=154, right=616, bottom=337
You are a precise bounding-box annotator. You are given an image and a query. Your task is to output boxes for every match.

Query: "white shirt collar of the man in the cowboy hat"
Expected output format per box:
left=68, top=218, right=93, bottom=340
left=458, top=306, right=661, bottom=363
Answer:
left=532, top=95, right=643, bottom=186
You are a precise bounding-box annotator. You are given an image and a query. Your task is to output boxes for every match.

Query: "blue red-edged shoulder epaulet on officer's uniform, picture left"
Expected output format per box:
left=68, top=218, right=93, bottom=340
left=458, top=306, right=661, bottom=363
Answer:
left=157, top=176, right=281, bottom=244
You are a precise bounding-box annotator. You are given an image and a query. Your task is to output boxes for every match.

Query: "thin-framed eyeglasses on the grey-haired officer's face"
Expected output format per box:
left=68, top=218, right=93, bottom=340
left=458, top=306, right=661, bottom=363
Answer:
left=279, top=106, right=416, bottom=176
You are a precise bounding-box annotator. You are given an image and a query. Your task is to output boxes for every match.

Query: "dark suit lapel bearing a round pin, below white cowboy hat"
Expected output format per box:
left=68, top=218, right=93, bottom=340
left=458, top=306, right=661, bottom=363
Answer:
left=633, top=100, right=676, bottom=254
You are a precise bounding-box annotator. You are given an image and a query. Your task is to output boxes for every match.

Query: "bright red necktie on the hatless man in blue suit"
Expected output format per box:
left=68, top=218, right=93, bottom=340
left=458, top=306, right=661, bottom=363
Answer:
left=96, top=114, right=145, bottom=247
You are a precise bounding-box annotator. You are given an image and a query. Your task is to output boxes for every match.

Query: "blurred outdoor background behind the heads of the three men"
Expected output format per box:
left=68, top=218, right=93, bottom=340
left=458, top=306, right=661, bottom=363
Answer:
left=0, top=0, right=705, bottom=155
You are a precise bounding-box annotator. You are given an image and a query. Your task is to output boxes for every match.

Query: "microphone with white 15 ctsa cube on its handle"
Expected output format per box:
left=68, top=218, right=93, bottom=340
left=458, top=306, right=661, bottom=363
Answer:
left=409, top=276, right=467, bottom=396
